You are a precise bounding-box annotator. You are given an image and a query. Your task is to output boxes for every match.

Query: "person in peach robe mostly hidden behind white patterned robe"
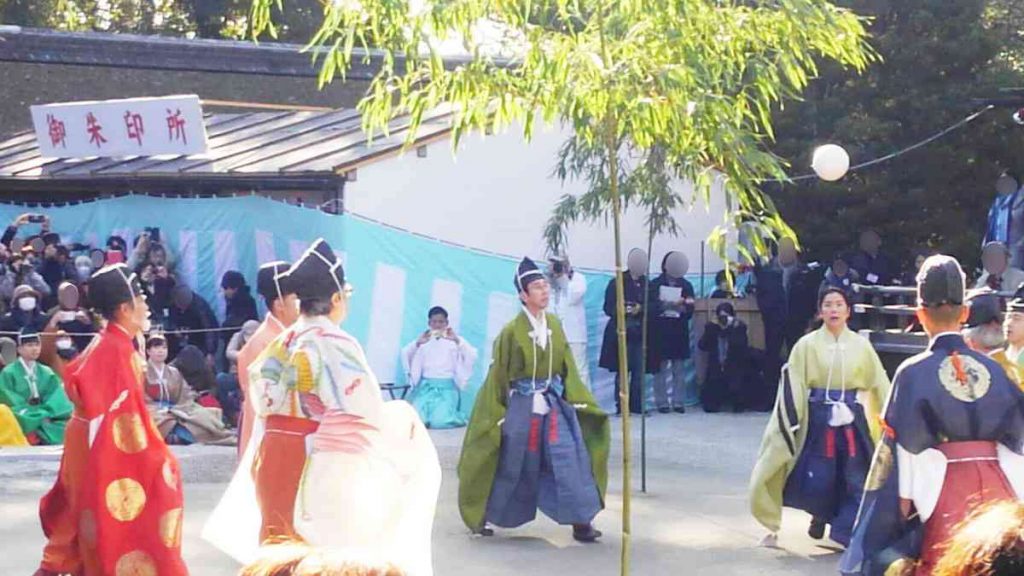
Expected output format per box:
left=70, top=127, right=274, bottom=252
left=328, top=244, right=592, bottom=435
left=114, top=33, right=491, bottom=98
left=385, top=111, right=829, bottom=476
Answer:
left=239, top=262, right=299, bottom=457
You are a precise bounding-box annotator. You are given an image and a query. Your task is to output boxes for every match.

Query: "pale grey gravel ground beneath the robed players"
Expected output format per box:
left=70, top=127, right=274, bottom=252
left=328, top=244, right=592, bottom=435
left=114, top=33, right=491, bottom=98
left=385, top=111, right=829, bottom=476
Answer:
left=0, top=412, right=838, bottom=576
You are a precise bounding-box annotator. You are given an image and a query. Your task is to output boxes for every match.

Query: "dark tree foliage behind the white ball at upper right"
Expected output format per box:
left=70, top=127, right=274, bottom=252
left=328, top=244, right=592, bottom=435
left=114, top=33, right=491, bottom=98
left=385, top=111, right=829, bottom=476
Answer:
left=765, top=0, right=1024, bottom=268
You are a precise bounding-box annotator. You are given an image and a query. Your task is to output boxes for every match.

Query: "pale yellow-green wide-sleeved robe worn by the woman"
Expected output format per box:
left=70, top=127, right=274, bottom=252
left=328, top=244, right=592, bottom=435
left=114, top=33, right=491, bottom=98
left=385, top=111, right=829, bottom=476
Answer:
left=750, top=327, right=889, bottom=532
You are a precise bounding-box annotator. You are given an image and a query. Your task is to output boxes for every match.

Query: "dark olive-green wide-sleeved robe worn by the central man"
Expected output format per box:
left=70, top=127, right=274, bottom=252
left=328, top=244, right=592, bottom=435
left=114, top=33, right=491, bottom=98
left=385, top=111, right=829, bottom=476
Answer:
left=458, top=312, right=611, bottom=530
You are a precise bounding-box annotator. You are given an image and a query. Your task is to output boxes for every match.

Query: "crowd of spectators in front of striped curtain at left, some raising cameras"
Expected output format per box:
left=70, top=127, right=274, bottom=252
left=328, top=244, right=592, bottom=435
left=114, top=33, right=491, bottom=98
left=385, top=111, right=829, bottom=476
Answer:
left=0, top=213, right=258, bottom=444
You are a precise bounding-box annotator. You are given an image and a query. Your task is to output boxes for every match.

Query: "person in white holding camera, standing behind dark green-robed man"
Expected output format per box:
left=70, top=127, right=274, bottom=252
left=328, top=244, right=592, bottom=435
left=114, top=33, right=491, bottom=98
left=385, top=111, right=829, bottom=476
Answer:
left=548, top=254, right=593, bottom=389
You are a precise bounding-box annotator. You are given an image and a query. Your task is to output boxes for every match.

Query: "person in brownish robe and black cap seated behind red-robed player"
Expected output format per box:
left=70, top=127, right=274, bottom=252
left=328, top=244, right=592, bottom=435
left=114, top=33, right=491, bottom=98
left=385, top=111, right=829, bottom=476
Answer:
left=144, top=333, right=238, bottom=446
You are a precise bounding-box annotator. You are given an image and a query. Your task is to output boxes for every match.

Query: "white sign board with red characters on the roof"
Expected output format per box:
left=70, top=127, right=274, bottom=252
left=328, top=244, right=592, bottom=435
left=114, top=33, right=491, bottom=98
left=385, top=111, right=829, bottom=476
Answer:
left=32, top=94, right=207, bottom=158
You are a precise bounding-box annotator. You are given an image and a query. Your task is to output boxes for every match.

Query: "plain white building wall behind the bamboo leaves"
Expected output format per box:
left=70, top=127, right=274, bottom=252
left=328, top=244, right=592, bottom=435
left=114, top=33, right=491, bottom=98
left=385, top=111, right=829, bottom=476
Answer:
left=345, top=121, right=724, bottom=273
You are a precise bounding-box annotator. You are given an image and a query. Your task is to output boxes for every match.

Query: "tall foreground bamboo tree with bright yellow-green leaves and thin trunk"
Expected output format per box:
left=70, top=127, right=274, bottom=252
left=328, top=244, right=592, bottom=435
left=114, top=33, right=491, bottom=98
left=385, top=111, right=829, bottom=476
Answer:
left=251, top=0, right=873, bottom=575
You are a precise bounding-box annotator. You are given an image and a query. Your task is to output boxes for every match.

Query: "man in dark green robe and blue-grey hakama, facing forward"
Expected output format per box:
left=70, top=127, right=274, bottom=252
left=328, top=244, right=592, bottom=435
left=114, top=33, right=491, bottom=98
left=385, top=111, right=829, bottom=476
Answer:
left=459, top=258, right=610, bottom=542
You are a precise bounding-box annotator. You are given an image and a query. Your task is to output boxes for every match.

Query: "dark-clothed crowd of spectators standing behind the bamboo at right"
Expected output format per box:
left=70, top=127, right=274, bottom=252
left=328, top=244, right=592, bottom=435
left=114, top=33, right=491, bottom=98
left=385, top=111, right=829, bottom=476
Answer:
left=599, top=222, right=1024, bottom=413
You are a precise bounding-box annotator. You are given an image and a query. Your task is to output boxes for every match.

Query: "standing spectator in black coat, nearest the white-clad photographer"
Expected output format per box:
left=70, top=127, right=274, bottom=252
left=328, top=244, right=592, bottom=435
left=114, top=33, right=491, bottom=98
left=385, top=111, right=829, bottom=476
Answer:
left=598, top=248, right=662, bottom=414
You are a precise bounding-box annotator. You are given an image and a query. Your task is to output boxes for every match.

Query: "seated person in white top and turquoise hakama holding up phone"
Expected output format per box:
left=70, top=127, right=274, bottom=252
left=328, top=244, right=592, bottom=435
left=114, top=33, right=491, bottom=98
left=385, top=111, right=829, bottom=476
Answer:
left=401, top=306, right=476, bottom=428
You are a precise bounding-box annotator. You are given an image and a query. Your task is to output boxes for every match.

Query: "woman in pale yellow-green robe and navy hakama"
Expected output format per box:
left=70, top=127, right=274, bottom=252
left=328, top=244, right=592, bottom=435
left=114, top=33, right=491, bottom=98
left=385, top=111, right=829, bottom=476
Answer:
left=750, top=290, right=889, bottom=545
